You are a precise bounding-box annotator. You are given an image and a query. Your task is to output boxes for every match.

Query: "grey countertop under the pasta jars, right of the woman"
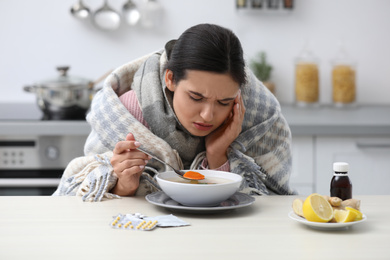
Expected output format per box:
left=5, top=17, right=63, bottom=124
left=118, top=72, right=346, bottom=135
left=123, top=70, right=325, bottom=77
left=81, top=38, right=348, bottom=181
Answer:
left=282, top=105, right=390, bottom=136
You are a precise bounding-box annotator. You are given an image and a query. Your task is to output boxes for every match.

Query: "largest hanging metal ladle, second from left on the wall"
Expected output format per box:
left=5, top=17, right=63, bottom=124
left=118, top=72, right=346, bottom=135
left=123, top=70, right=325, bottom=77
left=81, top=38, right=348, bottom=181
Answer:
left=93, top=0, right=121, bottom=31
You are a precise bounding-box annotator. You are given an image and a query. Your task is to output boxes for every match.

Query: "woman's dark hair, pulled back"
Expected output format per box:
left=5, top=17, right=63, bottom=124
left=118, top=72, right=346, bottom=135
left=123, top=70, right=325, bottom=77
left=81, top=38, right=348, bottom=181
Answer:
left=165, top=24, right=246, bottom=86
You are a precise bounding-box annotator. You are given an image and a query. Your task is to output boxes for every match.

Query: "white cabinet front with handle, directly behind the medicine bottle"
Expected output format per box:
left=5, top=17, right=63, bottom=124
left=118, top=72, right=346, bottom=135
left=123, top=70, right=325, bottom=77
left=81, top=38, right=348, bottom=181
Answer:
left=314, top=136, right=390, bottom=195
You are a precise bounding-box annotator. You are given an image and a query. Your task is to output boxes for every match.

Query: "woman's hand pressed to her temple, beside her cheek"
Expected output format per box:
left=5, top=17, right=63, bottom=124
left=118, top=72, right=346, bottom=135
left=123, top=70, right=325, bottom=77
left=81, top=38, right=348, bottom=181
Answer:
left=205, top=90, right=245, bottom=169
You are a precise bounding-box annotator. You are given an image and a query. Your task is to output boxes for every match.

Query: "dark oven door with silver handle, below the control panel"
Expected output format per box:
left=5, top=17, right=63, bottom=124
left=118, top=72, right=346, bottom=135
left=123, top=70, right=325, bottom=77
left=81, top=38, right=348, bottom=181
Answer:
left=0, top=169, right=64, bottom=196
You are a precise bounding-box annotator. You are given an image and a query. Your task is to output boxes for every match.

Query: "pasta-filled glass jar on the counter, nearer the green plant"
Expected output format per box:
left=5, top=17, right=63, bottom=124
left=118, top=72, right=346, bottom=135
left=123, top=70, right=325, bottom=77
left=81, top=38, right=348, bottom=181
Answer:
left=295, top=43, right=320, bottom=106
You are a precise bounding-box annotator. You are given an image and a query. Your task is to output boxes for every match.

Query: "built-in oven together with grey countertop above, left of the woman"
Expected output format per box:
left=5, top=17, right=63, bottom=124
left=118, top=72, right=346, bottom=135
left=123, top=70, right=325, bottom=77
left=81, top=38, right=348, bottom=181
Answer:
left=0, top=104, right=90, bottom=196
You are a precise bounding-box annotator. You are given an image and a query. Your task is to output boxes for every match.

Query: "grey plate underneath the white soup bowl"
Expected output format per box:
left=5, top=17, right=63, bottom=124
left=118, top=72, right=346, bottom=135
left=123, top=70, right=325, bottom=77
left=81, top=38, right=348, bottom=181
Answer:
left=145, top=191, right=255, bottom=214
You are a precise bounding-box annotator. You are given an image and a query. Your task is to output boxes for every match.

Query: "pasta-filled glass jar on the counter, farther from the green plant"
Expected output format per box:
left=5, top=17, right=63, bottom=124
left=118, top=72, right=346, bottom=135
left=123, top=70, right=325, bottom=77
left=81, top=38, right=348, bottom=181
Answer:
left=331, top=44, right=356, bottom=106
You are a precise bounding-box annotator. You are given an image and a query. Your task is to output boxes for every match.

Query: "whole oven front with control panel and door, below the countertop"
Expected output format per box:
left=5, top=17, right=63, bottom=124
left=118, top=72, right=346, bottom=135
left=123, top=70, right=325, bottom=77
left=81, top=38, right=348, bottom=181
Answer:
left=0, top=135, right=86, bottom=196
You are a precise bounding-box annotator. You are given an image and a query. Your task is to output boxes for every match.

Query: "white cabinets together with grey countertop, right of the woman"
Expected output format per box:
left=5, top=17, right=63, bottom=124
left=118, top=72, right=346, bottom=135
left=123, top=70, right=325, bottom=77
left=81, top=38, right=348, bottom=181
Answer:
left=282, top=105, right=390, bottom=195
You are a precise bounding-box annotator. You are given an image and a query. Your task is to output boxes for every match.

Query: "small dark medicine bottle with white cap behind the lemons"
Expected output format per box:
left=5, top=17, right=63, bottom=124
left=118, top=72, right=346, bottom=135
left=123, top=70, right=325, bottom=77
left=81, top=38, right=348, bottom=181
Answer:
left=330, top=162, right=352, bottom=200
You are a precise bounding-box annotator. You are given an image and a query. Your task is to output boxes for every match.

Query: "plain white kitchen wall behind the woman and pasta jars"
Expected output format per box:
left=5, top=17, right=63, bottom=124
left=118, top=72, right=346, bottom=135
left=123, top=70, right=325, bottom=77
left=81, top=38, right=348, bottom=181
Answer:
left=0, top=0, right=390, bottom=105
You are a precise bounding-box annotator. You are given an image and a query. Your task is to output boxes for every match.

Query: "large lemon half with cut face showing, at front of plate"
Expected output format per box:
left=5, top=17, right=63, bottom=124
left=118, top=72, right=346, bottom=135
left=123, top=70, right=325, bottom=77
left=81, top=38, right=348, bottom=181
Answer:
left=302, top=193, right=333, bottom=222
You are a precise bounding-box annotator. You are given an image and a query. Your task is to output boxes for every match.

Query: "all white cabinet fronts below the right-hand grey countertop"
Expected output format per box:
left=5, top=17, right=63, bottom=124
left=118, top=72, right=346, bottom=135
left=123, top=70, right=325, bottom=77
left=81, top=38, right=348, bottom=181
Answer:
left=290, top=135, right=390, bottom=195
